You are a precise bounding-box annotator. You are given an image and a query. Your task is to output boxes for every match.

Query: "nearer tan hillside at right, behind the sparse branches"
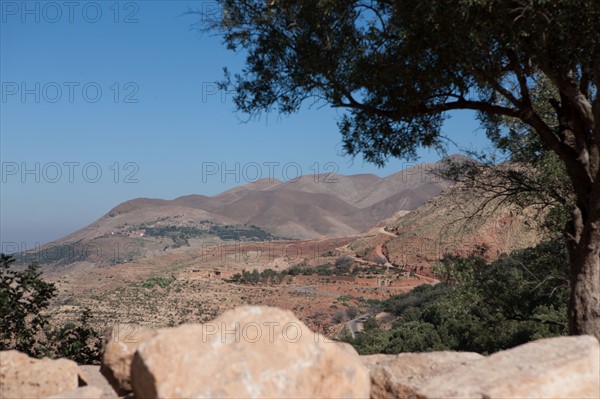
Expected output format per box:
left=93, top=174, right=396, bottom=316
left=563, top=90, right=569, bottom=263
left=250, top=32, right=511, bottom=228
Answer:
left=350, top=184, right=543, bottom=275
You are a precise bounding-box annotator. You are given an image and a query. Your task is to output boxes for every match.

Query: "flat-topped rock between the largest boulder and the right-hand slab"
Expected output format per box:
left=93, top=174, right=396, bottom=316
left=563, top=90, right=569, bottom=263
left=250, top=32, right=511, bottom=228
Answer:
left=361, top=352, right=484, bottom=398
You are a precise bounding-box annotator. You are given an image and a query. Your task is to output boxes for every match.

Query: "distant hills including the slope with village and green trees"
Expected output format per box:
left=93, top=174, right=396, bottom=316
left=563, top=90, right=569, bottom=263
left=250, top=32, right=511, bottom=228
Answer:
left=17, top=161, right=449, bottom=271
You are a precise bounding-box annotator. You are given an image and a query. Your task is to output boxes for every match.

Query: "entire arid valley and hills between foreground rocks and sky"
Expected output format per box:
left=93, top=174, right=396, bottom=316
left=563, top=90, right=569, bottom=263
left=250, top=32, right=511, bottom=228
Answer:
left=17, top=158, right=540, bottom=337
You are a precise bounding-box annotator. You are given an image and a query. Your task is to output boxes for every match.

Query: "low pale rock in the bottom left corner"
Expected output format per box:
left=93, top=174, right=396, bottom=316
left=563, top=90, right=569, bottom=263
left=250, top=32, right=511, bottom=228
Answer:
left=0, top=351, right=81, bottom=399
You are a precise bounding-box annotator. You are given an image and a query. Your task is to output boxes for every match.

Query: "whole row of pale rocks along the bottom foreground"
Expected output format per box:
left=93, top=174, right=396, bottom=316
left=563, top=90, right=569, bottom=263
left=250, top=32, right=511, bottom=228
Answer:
left=0, top=306, right=600, bottom=399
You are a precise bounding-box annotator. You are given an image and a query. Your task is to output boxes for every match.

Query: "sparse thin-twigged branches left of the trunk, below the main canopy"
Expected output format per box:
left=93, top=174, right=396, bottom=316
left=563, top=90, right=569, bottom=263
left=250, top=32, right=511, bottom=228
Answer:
left=438, top=78, right=575, bottom=237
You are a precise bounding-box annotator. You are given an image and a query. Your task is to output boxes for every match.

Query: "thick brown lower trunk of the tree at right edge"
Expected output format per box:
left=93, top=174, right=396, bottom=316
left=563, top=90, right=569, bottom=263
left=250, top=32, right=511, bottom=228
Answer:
left=567, top=200, right=600, bottom=340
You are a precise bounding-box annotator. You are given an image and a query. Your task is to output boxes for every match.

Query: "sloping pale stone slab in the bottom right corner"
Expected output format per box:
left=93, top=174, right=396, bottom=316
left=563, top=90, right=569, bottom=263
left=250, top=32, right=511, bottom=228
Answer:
left=418, top=336, right=600, bottom=398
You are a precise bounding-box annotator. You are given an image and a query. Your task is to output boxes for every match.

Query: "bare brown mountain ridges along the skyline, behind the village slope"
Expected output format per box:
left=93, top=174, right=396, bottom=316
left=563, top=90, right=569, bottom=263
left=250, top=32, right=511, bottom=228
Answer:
left=98, top=161, right=449, bottom=239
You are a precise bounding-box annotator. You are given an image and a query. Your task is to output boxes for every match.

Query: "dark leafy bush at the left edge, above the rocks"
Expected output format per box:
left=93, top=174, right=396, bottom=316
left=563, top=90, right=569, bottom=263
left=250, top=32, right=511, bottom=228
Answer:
left=0, top=254, right=101, bottom=364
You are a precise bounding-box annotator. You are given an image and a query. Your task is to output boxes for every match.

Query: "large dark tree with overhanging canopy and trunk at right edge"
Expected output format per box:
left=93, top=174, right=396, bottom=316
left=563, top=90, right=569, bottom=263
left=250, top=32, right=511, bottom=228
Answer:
left=204, top=0, right=600, bottom=338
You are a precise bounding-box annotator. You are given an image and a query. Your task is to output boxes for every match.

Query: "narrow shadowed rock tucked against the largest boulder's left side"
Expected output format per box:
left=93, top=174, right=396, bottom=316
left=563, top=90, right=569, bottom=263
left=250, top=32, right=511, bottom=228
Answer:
left=100, top=324, right=157, bottom=396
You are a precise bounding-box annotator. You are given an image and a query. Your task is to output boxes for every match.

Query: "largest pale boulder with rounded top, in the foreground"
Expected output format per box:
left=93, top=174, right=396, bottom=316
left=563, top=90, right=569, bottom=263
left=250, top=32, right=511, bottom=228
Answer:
left=131, top=306, right=370, bottom=398
